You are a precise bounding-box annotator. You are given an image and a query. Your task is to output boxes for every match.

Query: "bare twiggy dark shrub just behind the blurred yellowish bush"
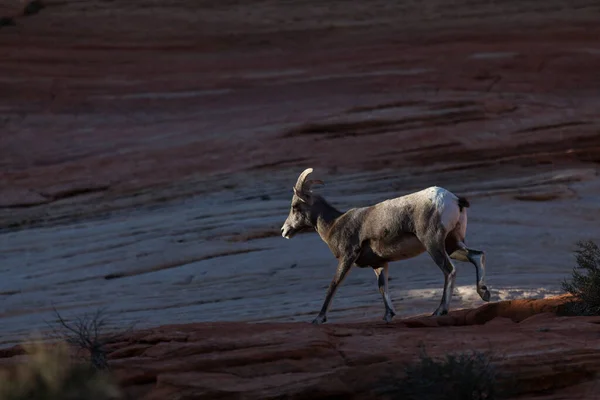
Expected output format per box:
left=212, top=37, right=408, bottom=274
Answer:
left=48, top=309, right=131, bottom=370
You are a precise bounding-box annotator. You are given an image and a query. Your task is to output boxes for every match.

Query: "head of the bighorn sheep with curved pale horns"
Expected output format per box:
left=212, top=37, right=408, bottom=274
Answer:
left=281, top=168, right=323, bottom=239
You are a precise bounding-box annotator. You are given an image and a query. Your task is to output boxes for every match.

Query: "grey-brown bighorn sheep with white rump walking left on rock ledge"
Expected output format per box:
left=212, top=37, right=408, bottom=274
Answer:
left=281, top=168, right=490, bottom=324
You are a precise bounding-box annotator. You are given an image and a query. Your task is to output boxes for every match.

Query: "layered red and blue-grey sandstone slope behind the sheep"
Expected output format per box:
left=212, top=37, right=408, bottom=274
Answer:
left=0, top=0, right=600, bottom=344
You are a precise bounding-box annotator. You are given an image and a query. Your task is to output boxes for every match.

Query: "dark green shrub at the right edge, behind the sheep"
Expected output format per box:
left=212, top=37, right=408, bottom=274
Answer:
left=562, top=240, right=600, bottom=315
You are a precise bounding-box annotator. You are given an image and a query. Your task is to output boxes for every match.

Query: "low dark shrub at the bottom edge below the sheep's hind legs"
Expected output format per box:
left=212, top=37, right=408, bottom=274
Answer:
left=378, top=348, right=508, bottom=400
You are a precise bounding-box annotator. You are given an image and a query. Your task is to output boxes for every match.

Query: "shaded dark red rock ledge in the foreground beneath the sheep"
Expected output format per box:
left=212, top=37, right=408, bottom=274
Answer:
left=0, top=296, right=600, bottom=400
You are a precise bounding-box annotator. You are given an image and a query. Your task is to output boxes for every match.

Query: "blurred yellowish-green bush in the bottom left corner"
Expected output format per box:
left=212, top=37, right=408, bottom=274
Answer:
left=0, top=341, right=123, bottom=400
